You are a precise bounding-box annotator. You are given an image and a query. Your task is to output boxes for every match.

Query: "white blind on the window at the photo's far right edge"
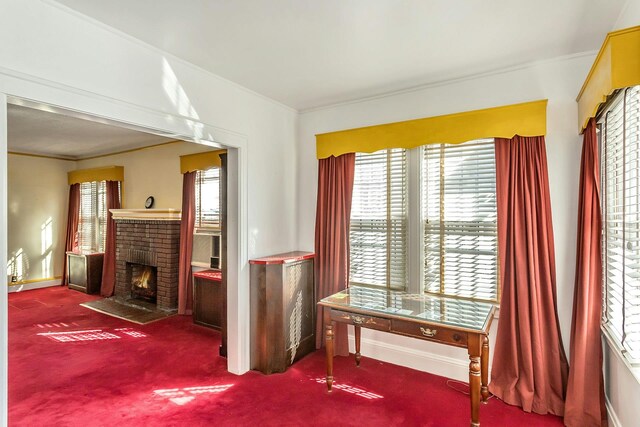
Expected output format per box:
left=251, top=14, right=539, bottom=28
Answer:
left=600, top=86, right=640, bottom=362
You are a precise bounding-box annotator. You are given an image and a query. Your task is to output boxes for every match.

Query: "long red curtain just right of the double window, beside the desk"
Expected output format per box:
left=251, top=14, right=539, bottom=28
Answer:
left=489, top=135, right=568, bottom=415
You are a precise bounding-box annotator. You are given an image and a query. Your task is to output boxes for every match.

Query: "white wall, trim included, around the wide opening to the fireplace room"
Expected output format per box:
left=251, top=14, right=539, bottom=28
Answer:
left=0, top=0, right=297, bottom=408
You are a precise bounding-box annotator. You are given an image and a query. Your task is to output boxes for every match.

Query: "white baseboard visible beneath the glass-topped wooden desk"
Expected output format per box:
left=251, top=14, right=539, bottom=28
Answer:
left=349, top=333, right=469, bottom=382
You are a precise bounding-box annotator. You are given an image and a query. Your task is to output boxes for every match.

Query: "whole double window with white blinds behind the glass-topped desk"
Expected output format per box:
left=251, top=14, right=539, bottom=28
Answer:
left=350, top=139, right=499, bottom=302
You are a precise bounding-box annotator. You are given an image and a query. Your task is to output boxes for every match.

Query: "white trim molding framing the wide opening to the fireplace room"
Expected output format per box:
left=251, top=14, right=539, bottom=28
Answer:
left=0, top=62, right=250, bottom=378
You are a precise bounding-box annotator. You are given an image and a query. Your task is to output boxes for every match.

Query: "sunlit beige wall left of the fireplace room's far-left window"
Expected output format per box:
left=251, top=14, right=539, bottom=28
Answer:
left=7, top=154, right=75, bottom=280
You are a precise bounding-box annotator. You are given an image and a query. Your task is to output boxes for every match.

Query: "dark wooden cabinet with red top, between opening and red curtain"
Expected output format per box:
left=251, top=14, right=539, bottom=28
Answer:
left=249, top=252, right=316, bottom=374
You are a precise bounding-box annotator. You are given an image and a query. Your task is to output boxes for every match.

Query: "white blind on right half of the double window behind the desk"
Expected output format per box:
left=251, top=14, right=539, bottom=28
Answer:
left=422, top=139, right=499, bottom=301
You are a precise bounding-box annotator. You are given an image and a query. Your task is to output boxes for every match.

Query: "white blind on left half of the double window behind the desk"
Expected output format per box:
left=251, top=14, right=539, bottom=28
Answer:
left=349, top=149, right=408, bottom=289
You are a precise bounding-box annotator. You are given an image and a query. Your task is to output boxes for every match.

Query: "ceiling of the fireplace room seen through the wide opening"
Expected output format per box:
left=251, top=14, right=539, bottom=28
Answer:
left=7, top=104, right=175, bottom=160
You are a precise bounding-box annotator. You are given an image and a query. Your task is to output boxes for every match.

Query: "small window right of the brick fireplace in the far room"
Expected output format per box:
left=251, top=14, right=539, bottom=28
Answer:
left=195, top=167, right=220, bottom=229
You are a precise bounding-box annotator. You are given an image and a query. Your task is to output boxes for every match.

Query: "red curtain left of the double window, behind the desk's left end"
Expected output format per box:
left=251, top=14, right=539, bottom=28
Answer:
left=315, top=153, right=356, bottom=356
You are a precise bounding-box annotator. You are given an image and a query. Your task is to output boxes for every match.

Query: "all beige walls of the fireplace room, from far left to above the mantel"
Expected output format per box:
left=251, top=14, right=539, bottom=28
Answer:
left=8, top=141, right=210, bottom=281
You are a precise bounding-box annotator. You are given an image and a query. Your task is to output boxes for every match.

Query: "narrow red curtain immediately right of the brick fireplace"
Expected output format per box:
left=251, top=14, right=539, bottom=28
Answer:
left=178, top=172, right=196, bottom=314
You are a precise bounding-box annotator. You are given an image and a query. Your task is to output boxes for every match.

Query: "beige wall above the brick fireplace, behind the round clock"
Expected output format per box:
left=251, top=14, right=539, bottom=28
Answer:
left=77, top=141, right=208, bottom=209
